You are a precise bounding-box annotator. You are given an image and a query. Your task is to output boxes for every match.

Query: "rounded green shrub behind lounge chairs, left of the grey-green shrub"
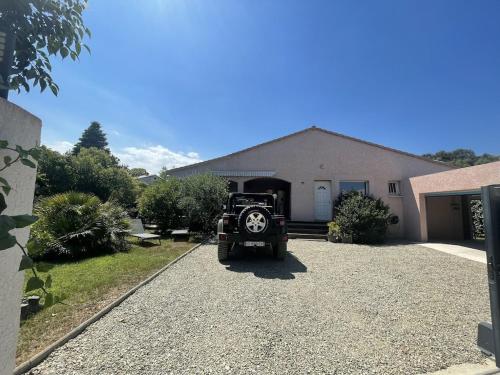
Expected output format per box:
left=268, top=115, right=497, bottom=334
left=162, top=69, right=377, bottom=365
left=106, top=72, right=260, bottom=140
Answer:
left=138, top=178, right=182, bottom=231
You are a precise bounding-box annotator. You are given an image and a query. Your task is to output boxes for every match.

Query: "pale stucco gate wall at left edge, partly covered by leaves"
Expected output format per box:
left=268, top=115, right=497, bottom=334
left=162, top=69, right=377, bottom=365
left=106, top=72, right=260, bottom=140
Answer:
left=0, top=98, right=41, bottom=375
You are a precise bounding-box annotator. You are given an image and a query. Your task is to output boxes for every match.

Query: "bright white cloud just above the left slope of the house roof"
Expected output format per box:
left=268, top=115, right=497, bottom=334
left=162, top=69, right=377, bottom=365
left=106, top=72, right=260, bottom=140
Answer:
left=113, top=145, right=202, bottom=173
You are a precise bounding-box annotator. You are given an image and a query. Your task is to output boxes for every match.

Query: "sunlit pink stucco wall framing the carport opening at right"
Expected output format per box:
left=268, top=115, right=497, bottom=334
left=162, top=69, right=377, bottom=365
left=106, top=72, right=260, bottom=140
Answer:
left=403, top=162, right=500, bottom=241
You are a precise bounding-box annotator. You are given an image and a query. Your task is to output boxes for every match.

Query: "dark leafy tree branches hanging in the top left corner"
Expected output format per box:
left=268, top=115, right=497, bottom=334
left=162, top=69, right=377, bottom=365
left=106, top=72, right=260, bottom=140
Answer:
left=0, top=0, right=90, bottom=95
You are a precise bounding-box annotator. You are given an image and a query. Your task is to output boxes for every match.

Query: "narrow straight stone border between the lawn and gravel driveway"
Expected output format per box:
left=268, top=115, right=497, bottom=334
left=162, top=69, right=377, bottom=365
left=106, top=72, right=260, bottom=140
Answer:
left=13, top=242, right=205, bottom=375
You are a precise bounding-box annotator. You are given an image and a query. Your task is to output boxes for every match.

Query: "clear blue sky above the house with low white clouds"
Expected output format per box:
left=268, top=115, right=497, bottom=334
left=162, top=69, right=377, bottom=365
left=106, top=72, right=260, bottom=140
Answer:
left=10, top=0, right=500, bottom=172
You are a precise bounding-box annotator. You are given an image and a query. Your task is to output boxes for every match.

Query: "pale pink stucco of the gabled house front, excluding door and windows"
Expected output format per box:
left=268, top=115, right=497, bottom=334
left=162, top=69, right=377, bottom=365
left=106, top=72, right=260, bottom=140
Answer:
left=170, top=128, right=449, bottom=236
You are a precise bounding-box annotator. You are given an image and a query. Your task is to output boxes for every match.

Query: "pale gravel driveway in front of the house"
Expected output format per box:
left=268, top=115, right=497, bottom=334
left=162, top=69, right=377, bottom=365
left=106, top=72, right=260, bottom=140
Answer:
left=32, top=240, right=489, bottom=375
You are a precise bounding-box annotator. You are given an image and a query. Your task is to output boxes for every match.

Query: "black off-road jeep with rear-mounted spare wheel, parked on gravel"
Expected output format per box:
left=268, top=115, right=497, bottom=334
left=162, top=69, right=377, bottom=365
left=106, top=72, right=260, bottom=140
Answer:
left=217, top=193, right=288, bottom=261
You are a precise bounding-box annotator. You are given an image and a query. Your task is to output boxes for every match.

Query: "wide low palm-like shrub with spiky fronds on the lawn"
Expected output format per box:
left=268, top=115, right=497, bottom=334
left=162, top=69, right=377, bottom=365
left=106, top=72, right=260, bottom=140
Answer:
left=29, top=192, right=128, bottom=258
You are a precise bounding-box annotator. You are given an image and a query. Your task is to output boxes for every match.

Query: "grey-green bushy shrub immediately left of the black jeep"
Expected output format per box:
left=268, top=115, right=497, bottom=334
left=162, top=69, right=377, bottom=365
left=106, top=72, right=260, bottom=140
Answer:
left=180, top=174, right=228, bottom=233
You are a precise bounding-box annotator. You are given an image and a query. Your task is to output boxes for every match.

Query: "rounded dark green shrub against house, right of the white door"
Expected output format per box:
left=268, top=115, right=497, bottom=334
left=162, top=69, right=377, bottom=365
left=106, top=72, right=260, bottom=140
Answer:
left=335, top=191, right=391, bottom=244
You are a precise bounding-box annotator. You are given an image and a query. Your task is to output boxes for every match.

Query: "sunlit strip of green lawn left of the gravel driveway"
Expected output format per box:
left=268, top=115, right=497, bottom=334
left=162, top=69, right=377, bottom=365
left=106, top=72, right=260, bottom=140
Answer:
left=16, top=240, right=194, bottom=364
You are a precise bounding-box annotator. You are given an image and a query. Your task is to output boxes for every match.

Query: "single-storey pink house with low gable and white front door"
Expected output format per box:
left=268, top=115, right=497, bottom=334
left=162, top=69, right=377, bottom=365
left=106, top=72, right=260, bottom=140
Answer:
left=168, top=126, right=453, bottom=239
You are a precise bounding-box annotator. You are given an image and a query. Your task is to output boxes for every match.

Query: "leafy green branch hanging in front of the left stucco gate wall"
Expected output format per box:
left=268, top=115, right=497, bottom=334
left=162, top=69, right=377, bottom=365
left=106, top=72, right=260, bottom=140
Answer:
left=0, top=140, right=57, bottom=306
